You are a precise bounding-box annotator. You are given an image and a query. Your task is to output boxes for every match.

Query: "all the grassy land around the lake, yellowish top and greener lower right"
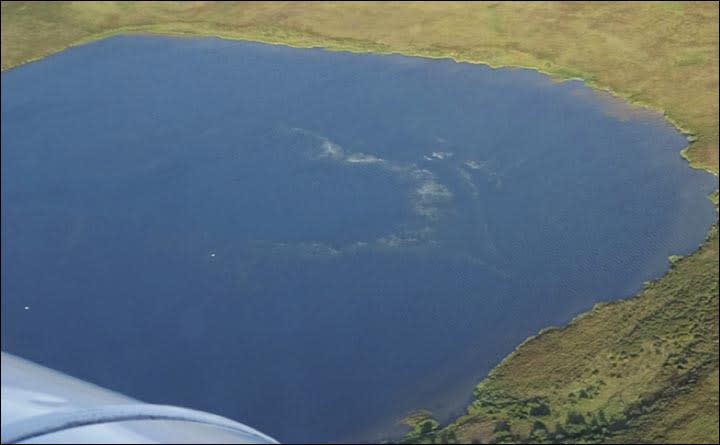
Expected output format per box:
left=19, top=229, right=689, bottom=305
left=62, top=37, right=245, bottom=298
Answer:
left=2, top=2, right=718, bottom=442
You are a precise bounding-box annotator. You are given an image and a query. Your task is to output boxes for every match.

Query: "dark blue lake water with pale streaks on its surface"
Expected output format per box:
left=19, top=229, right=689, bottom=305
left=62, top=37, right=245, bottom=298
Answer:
left=2, top=37, right=716, bottom=441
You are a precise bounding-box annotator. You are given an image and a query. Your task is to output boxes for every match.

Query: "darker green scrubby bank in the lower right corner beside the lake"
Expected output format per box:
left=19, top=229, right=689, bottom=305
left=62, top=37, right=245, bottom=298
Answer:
left=408, top=227, right=718, bottom=443
